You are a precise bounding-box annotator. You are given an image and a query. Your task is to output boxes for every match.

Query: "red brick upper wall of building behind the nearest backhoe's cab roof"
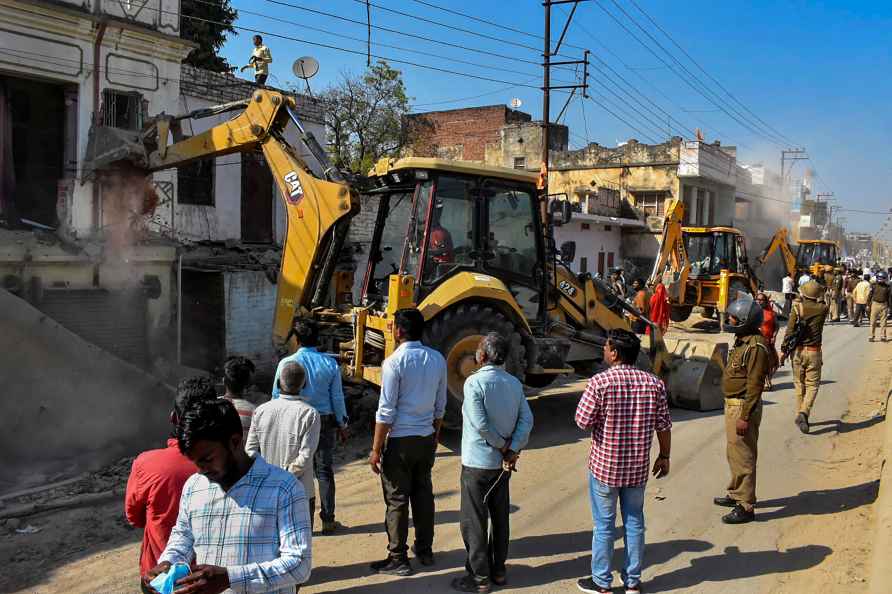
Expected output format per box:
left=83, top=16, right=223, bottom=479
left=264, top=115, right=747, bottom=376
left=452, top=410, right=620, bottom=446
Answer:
left=408, top=105, right=532, bottom=163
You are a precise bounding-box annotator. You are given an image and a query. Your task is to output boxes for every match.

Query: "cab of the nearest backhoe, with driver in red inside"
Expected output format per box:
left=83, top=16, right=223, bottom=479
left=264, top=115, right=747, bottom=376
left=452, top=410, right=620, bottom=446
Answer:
left=360, top=159, right=545, bottom=318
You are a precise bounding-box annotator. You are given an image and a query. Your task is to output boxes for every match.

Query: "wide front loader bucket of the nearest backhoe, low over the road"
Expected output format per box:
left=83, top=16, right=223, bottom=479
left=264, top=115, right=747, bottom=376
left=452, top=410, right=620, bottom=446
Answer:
left=663, top=337, right=728, bottom=411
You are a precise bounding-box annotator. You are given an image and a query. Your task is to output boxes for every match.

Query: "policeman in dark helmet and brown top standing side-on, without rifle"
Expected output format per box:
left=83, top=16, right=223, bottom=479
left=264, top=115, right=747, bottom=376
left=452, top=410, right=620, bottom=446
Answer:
left=714, top=297, right=771, bottom=524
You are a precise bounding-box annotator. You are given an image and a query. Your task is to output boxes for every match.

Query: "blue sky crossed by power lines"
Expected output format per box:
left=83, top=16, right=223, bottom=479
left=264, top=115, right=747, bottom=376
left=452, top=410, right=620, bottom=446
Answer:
left=224, top=0, right=892, bottom=239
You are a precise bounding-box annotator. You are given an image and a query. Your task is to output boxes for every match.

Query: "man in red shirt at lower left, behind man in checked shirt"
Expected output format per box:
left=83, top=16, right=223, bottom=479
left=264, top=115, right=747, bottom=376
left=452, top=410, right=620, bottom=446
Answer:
left=124, top=377, right=217, bottom=575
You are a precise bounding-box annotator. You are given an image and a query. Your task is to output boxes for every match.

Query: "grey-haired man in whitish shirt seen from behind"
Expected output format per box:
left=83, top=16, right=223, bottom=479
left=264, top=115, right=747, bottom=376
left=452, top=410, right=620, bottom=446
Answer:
left=245, top=362, right=322, bottom=529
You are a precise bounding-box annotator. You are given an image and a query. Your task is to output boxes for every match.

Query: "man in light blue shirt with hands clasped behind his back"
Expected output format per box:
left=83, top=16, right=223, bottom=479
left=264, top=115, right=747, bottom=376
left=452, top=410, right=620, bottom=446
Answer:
left=452, top=332, right=533, bottom=592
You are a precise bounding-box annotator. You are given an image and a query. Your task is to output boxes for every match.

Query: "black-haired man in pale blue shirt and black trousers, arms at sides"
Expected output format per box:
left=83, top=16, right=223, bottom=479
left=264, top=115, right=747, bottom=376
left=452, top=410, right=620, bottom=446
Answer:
left=369, top=309, right=446, bottom=576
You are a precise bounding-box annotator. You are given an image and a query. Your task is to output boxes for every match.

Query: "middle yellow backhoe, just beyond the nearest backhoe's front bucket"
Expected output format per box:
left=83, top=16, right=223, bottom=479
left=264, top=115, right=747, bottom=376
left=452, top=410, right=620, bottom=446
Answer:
left=649, top=200, right=759, bottom=326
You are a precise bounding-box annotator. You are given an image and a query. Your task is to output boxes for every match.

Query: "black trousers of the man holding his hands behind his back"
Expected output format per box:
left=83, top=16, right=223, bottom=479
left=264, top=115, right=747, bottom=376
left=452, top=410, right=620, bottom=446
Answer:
left=461, top=466, right=511, bottom=584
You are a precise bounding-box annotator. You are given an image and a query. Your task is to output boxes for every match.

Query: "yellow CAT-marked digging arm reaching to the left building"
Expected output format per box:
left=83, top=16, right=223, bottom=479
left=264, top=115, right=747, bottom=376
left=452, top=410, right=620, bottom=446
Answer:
left=96, top=89, right=359, bottom=345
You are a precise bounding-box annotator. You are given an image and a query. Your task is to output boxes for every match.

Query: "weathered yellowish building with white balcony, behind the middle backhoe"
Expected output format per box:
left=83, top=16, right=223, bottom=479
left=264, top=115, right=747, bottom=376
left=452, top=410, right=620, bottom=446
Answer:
left=548, top=137, right=736, bottom=277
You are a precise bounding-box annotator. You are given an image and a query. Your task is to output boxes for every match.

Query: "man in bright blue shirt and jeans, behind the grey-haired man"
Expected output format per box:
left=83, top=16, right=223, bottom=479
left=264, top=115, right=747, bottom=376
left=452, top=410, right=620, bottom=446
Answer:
left=273, top=318, right=348, bottom=534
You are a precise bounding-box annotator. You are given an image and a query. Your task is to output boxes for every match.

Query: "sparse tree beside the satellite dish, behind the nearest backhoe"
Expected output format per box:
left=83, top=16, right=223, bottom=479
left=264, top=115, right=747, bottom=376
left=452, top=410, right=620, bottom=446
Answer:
left=320, top=60, right=426, bottom=174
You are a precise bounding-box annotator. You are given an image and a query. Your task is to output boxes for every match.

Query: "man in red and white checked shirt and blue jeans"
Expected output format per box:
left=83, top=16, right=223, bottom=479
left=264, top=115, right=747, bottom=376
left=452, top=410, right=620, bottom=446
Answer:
left=576, top=330, right=672, bottom=594
